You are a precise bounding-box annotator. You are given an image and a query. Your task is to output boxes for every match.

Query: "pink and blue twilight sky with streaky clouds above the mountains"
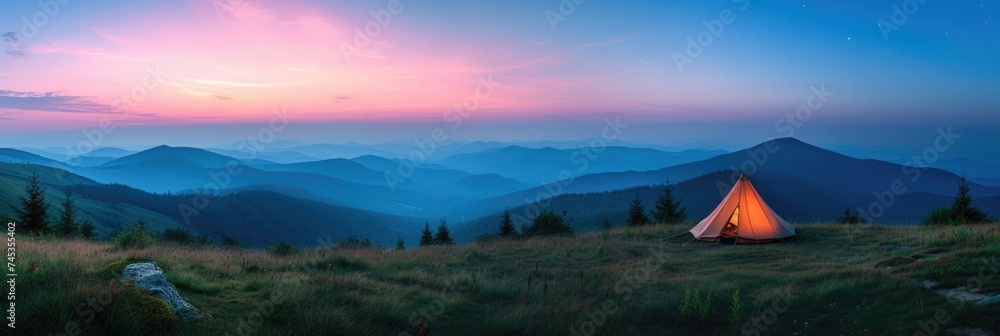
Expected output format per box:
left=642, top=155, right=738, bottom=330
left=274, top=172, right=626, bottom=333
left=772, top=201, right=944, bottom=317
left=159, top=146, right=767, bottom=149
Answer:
left=0, top=0, right=1000, bottom=151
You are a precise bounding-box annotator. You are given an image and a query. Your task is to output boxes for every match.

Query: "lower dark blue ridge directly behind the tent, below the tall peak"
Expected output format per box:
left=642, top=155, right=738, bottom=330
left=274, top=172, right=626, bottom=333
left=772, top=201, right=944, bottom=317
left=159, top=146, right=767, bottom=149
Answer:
left=453, top=171, right=1000, bottom=241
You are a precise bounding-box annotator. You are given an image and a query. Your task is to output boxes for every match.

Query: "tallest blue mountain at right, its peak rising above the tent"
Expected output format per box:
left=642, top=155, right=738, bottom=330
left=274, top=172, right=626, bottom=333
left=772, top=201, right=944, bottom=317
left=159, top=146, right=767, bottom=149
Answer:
left=466, top=138, right=1000, bottom=222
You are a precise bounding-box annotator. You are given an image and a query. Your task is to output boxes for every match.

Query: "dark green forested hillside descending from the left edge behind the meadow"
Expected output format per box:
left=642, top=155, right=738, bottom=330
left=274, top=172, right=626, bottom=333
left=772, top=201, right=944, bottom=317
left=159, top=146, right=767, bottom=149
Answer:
left=0, top=163, right=422, bottom=246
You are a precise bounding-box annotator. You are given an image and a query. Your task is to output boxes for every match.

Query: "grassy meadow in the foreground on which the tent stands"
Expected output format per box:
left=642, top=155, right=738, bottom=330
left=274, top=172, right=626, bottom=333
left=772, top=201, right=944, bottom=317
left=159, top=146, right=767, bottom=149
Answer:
left=16, top=225, right=1000, bottom=335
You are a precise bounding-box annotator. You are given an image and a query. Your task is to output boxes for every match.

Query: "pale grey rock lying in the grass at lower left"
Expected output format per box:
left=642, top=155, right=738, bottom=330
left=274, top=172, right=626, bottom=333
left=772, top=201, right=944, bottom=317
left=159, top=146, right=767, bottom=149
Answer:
left=121, top=262, right=201, bottom=319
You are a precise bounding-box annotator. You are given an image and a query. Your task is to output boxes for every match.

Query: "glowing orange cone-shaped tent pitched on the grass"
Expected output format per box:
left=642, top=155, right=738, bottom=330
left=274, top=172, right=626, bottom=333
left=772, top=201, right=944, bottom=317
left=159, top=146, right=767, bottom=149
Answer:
left=690, top=174, right=795, bottom=243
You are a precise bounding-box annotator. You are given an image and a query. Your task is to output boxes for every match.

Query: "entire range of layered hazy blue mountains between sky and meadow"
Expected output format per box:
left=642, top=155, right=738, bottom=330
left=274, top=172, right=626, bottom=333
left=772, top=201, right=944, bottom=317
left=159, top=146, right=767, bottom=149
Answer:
left=0, top=138, right=1000, bottom=245
